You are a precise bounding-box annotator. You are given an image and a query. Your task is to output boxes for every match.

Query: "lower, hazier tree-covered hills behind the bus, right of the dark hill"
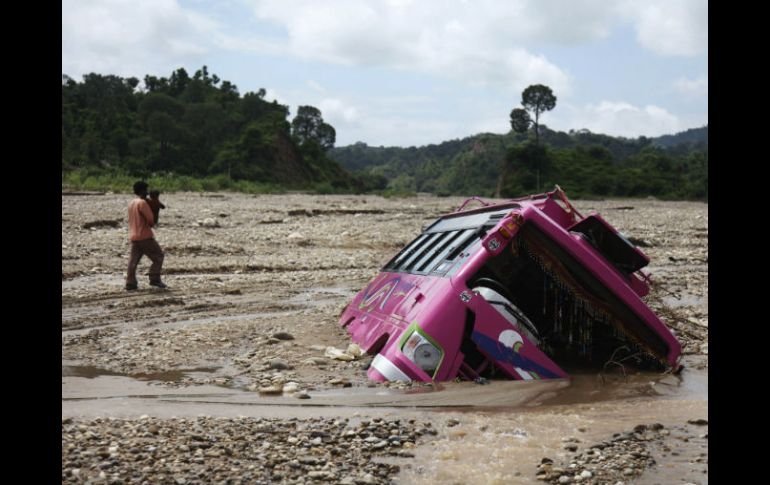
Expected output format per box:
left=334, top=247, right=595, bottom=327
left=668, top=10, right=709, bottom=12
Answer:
left=330, top=126, right=708, bottom=199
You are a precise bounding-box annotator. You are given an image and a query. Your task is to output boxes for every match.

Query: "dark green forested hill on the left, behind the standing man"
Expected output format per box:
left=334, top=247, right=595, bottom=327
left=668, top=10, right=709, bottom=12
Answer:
left=62, top=66, right=361, bottom=191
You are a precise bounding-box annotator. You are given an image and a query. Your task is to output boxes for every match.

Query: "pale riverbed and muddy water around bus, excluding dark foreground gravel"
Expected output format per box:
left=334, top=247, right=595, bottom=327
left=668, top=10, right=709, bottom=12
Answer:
left=62, top=193, right=708, bottom=483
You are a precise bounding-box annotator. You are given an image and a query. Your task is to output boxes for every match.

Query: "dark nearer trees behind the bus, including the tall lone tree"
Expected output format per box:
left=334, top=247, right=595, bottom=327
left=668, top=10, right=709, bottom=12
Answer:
left=496, top=84, right=708, bottom=200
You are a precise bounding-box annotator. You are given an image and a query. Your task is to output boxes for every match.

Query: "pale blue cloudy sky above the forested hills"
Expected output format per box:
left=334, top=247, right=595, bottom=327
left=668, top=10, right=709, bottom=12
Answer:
left=62, top=0, right=708, bottom=147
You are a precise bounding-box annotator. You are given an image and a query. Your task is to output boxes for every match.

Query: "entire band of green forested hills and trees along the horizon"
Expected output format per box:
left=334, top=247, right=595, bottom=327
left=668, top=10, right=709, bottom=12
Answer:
left=62, top=66, right=708, bottom=200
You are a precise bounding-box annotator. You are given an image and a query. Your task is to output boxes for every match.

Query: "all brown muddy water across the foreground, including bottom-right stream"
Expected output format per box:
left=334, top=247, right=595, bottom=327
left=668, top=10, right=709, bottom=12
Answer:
left=62, top=358, right=708, bottom=485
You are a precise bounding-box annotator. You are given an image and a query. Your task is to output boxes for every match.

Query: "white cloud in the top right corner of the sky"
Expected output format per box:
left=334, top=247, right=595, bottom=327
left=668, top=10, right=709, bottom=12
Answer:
left=618, top=0, right=708, bottom=56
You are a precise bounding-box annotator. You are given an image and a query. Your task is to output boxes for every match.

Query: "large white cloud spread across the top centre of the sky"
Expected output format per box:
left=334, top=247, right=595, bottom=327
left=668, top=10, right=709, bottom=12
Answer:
left=243, top=0, right=580, bottom=93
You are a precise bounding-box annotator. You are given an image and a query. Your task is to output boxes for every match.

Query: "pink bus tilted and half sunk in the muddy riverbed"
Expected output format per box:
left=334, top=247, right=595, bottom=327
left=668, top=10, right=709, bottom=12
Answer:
left=340, top=186, right=681, bottom=381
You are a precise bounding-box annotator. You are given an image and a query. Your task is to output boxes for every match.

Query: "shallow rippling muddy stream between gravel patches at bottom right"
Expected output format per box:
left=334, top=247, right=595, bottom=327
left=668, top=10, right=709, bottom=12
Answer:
left=400, top=400, right=708, bottom=484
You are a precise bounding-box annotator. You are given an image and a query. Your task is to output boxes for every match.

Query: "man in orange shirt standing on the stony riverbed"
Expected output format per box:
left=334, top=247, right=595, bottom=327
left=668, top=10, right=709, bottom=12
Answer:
left=126, top=182, right=166, bottom=290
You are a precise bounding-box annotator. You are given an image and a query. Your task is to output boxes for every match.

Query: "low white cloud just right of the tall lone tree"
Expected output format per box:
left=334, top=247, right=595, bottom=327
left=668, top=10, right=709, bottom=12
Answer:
left=559, top=101, right=690, bottom=138
